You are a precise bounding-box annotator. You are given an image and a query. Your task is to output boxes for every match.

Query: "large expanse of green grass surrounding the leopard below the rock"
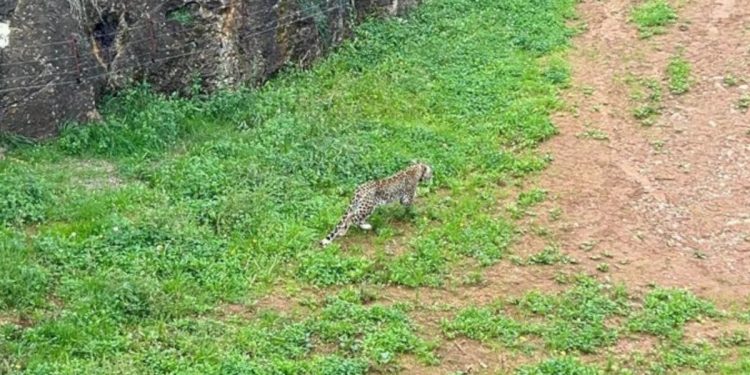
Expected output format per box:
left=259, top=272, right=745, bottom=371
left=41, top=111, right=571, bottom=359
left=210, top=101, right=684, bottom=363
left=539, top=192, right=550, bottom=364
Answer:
left=0, top=0, right=575, bottom=374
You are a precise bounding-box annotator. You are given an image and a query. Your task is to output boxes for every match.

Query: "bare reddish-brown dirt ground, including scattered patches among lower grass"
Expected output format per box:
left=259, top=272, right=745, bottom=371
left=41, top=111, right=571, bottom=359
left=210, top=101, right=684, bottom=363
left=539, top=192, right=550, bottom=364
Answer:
left=213, top=0, right=750, bottom=374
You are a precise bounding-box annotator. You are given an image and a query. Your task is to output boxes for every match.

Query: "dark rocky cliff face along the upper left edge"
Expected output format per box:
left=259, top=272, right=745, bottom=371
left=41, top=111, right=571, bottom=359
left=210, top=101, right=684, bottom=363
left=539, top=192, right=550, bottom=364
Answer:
left=0, top=0, right=419, bottom=138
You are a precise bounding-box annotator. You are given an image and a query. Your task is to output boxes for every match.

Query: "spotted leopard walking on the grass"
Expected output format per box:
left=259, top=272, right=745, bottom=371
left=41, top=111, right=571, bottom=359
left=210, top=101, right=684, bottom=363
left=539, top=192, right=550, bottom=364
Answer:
left=320, top=163, right=432, bottom=246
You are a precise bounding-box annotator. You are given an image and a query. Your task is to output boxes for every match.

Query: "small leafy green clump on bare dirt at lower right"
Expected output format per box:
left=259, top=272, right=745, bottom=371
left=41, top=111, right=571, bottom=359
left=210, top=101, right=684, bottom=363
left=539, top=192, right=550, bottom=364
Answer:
left=628, top=288, right=717, bottom=339
